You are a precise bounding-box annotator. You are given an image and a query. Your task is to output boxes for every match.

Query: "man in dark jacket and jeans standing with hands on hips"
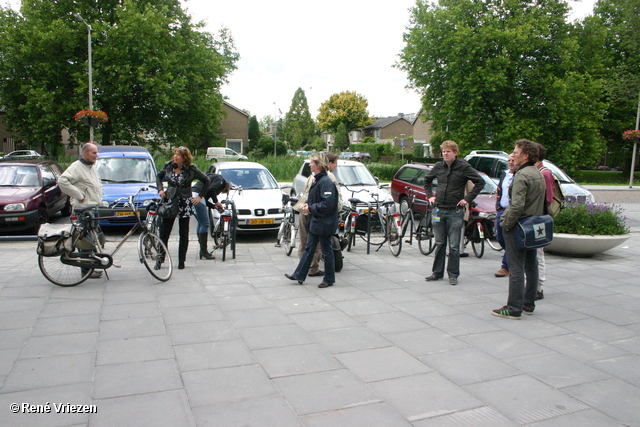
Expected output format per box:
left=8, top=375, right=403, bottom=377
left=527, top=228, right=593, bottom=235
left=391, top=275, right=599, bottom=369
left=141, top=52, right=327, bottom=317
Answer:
left=424, top=141, right=484, bottom=285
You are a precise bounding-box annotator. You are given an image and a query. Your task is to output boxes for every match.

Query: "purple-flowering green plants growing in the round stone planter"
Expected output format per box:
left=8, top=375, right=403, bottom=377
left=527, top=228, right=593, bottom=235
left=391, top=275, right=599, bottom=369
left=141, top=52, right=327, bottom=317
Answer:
left=553, top=203, right=629, bottom=236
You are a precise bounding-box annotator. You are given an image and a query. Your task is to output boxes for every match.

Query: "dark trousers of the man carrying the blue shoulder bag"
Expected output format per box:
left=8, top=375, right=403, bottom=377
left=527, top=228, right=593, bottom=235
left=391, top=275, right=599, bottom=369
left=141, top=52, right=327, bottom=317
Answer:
left=503, top=229, right=538, bottom=315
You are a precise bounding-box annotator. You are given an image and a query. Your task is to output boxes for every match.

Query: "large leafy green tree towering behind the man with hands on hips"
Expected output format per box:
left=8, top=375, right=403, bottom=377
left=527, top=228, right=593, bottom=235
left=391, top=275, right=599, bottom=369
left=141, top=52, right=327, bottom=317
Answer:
left=397, top=0, right=605, bottom=169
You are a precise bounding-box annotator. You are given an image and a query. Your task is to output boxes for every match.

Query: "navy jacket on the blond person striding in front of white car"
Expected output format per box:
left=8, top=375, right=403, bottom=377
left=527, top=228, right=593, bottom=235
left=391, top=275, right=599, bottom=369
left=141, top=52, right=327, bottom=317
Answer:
left=307, top=172, right=338, bottom=236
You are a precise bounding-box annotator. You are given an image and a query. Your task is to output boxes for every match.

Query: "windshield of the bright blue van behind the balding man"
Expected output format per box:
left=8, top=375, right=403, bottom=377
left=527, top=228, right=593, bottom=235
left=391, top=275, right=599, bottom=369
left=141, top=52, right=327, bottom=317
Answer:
left=96, top=157, right=156, bottom=184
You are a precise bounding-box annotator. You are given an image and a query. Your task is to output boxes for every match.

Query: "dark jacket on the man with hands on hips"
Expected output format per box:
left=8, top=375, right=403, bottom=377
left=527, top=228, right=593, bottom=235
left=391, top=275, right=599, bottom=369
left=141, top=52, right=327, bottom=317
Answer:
left=424, top=159, right=485, bottom=208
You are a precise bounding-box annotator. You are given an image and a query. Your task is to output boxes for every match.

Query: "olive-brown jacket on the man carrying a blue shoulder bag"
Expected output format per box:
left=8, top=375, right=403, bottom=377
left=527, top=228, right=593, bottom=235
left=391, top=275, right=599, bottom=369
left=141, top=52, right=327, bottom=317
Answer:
left=500, top=163, right=546, bottom=231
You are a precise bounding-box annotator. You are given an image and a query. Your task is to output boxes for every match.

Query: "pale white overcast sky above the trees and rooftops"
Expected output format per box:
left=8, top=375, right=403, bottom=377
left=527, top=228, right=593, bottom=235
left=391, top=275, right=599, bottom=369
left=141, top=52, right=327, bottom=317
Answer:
left=182, top=0, right=595, bottom=119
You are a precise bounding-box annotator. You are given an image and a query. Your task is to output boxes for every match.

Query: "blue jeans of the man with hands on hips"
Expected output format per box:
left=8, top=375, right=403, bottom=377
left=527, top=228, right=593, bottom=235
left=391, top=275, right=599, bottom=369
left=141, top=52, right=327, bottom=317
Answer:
left=432, top=207, right=464, bottom=278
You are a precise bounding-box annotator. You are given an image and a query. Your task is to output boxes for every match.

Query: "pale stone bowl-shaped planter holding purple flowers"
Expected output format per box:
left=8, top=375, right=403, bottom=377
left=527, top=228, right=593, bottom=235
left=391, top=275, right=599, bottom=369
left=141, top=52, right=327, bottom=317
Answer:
left=545, top=233, right=631, bottom=257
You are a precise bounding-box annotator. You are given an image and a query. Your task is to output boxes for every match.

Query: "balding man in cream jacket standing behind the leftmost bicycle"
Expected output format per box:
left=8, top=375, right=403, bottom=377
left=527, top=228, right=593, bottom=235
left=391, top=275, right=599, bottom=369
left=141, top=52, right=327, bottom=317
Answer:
left=58, top=142, right=102, bottom=279
